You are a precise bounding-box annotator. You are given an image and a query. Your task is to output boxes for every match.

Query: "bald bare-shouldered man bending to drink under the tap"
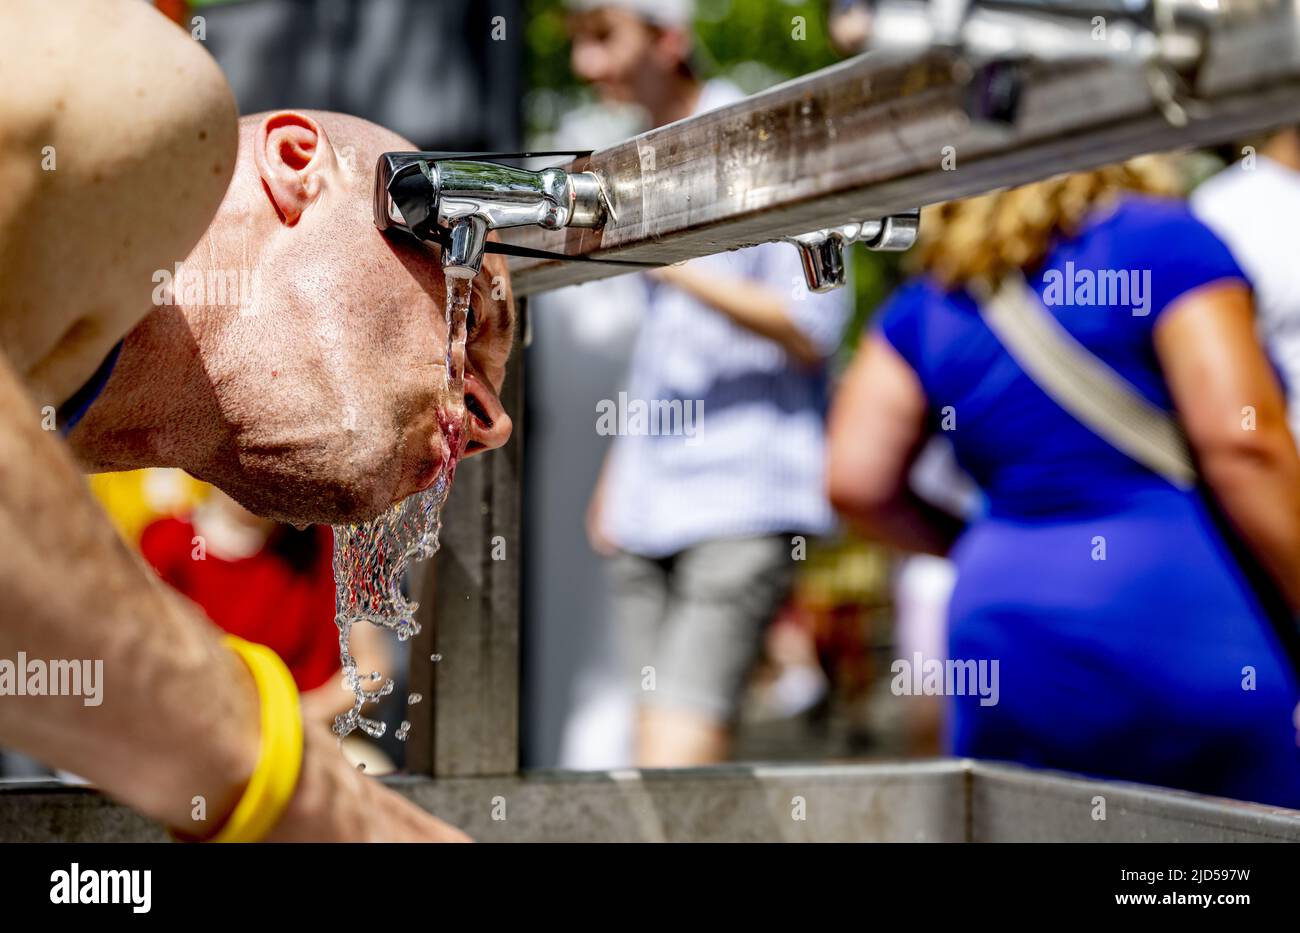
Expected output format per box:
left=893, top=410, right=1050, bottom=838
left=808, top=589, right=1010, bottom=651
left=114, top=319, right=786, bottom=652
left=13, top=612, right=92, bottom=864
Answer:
left=0, top=0, right=514, bottom=841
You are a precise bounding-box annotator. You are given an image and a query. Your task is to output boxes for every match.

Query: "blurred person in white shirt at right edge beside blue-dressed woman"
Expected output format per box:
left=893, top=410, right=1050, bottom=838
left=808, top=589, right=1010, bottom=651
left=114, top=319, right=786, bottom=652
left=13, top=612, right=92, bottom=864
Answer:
left=1192, top=126, right=1300, bottom=447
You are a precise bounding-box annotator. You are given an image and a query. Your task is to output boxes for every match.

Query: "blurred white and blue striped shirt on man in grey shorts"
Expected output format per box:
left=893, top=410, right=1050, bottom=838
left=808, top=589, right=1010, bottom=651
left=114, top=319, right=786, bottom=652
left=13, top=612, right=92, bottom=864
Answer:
left=598, top=243, right=850, bottom=556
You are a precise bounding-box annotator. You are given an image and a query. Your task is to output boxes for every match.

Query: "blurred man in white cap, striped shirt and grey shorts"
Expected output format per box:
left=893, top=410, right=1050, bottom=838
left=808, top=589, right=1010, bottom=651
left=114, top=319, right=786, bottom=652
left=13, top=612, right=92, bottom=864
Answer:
left=571, top=0, right=849, bottom=767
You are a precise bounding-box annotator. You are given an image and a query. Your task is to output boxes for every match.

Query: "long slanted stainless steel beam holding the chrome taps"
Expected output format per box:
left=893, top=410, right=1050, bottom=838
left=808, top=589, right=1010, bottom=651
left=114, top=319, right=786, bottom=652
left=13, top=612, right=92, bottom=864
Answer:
left=506, top=1, right=1300, bottom=294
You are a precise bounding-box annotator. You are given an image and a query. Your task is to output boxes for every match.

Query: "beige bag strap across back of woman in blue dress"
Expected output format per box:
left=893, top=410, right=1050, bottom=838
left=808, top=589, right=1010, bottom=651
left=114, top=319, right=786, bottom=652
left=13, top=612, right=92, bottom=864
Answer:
left=979, top=274, right=1196, bottom=489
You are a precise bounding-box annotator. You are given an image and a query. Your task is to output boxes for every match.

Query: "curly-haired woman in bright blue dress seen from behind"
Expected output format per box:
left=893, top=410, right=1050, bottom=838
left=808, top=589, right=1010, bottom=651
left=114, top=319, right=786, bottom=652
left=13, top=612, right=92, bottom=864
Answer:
left=828, top=164, right=1300, bottom=808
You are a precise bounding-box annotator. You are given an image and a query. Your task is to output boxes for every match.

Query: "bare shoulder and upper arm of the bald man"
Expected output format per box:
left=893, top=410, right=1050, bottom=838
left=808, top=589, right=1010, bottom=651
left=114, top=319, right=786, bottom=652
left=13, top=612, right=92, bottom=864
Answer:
left=0, top=0, right=238, bottom=404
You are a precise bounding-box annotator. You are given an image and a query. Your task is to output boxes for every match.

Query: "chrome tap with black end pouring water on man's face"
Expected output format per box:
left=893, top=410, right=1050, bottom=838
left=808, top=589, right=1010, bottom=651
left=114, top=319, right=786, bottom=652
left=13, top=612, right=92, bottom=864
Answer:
left=374, top=152, right=607, bottom=278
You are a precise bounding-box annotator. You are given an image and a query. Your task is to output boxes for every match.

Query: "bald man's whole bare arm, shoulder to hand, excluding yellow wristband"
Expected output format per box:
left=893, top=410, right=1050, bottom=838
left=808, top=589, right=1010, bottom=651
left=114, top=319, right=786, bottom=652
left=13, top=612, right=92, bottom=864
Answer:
left=0, top=0, right=464, bottom=841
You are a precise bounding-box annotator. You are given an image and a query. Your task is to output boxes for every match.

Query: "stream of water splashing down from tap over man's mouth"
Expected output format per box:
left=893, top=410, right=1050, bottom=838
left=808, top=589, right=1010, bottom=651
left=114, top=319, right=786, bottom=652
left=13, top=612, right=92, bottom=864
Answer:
left=334, top=277, right=472, bottom=739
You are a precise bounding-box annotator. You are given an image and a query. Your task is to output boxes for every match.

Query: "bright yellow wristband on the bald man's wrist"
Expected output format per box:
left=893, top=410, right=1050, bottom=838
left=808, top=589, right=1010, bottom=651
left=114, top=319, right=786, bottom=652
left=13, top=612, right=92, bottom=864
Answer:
left=183, top=635, right=303, bottom=842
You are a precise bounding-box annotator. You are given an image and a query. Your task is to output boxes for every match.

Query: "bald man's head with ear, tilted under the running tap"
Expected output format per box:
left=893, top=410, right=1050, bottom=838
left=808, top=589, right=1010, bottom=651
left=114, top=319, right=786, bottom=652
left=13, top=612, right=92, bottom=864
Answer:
left=89, top=110, right=514, bottom=522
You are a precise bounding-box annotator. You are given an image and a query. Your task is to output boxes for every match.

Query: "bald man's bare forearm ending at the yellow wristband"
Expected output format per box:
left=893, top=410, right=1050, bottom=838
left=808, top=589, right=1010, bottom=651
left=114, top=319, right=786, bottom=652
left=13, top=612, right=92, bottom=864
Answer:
left=0, top=357, right=257, bottom=832
